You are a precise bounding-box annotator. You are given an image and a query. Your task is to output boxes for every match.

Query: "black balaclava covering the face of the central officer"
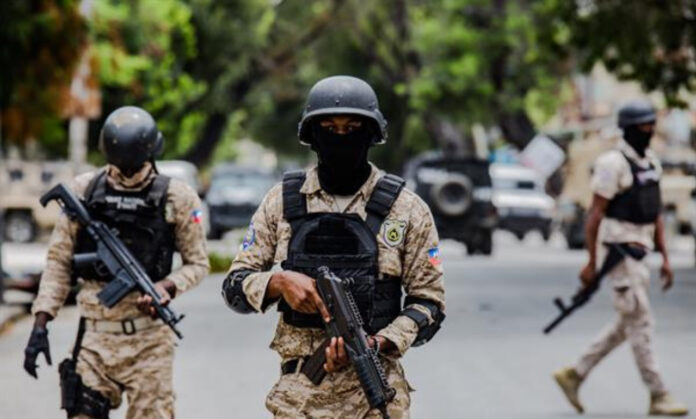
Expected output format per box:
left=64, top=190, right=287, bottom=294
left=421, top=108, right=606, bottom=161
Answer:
left=312, top=122, right=372, bottom=195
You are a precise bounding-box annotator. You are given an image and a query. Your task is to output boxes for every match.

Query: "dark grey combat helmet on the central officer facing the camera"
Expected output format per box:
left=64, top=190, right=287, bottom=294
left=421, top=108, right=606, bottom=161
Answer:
left=297, top=76, right=387, bottom=145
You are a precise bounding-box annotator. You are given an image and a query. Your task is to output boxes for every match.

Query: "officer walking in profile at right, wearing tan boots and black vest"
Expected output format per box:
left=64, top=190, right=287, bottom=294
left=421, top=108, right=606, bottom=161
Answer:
left=554, top=102, right=688, bottom=416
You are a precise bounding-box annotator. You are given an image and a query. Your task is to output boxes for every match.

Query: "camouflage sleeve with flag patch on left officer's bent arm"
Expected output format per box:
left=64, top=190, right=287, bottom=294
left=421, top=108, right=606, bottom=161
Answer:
left=166, top=179, right=210, bottom=294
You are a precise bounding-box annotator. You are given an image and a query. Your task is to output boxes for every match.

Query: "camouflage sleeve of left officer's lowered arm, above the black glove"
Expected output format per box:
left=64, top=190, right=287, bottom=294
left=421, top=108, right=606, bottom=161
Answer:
left=31, top=172, right=96, bottom=317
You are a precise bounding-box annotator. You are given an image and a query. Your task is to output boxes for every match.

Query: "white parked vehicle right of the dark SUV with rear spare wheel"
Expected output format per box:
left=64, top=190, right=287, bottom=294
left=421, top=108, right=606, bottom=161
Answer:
left=490, top=164, right=555, bottom=240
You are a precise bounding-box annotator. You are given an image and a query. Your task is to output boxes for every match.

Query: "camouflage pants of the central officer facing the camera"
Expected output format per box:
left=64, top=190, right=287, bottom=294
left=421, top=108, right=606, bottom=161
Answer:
left=266, top=358, right=412, bottom=419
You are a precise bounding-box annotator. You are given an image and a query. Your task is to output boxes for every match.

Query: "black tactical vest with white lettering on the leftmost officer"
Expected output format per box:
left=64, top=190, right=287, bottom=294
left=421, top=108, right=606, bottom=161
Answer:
left=73, top=171, right=176, bottom=281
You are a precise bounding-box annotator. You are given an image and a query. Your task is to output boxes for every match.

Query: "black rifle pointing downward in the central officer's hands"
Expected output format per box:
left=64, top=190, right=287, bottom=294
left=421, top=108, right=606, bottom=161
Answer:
left=302, top=266, right=396, bottom=419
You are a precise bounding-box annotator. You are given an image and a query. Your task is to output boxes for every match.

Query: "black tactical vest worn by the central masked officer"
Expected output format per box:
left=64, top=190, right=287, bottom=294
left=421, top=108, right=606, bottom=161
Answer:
left=278, top=171, right=404, bottom=334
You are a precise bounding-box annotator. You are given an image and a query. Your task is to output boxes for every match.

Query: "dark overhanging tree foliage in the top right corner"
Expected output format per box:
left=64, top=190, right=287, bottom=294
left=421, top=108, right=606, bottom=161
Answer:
left=560, top=0, right=696, bottom=106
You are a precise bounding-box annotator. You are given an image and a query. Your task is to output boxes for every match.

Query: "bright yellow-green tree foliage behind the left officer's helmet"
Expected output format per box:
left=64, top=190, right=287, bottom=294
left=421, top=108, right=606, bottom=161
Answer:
left=90, top=0, right=208, bottom=157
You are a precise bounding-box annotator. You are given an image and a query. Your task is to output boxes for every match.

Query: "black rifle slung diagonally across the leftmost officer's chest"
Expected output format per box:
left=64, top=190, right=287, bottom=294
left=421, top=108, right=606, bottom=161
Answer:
left=40, top=183, right=184, bottom=339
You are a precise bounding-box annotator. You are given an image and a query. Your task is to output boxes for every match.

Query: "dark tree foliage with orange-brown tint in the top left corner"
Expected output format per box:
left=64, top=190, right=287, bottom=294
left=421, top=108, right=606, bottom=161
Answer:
left=0, top=0, right=87, bottom=154
